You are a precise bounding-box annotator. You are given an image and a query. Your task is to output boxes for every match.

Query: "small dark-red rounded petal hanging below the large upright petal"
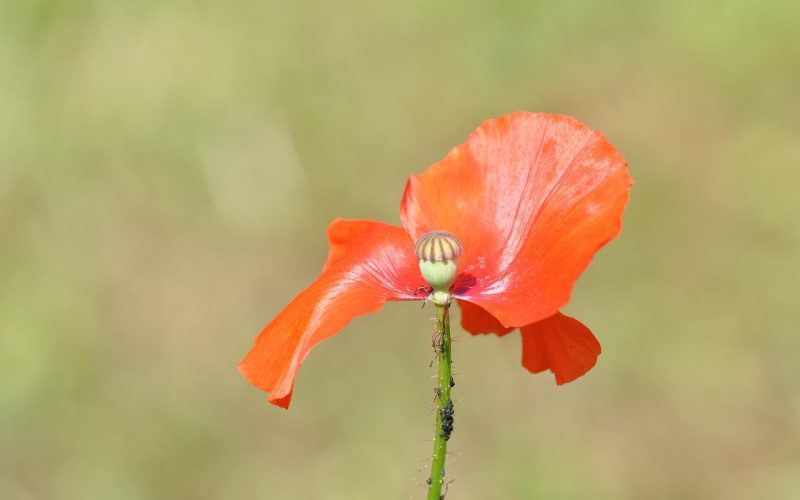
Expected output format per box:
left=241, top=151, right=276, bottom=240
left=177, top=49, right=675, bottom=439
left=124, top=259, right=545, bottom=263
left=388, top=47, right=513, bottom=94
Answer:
left=520, top=313, right=600, bottom=385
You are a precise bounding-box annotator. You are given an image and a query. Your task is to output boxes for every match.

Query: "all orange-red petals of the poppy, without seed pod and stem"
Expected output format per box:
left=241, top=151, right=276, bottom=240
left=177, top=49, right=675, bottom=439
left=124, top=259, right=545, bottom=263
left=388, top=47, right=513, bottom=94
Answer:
left=239, top=112, right=632, bottom=408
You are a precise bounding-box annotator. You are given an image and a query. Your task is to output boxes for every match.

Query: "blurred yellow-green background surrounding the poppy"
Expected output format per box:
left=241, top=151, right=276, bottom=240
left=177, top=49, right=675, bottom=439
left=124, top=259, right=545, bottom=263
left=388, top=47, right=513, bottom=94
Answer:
left=0, top=0, right=800, bottom=500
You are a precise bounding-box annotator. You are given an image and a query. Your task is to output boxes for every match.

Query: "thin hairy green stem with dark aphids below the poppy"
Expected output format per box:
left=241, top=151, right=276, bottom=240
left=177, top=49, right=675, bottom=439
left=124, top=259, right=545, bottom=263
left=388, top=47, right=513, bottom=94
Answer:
left=428, top=303, right=453, bottom=500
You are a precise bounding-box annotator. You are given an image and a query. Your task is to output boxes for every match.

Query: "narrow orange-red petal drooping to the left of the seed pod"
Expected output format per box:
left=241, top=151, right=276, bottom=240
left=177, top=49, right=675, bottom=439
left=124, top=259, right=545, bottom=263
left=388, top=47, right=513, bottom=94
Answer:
left=239, top=219, right=424, bottom=408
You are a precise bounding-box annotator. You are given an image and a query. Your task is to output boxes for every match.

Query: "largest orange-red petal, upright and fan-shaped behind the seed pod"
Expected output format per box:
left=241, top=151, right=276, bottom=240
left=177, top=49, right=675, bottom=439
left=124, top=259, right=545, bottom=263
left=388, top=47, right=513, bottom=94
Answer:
left=400, top=113, right=631, bottom=326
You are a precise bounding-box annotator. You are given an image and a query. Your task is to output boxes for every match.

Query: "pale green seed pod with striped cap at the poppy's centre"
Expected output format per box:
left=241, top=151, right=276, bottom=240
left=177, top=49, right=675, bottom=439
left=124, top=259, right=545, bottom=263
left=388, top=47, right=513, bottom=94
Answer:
left=414, top=231, right=461, bottom=305
